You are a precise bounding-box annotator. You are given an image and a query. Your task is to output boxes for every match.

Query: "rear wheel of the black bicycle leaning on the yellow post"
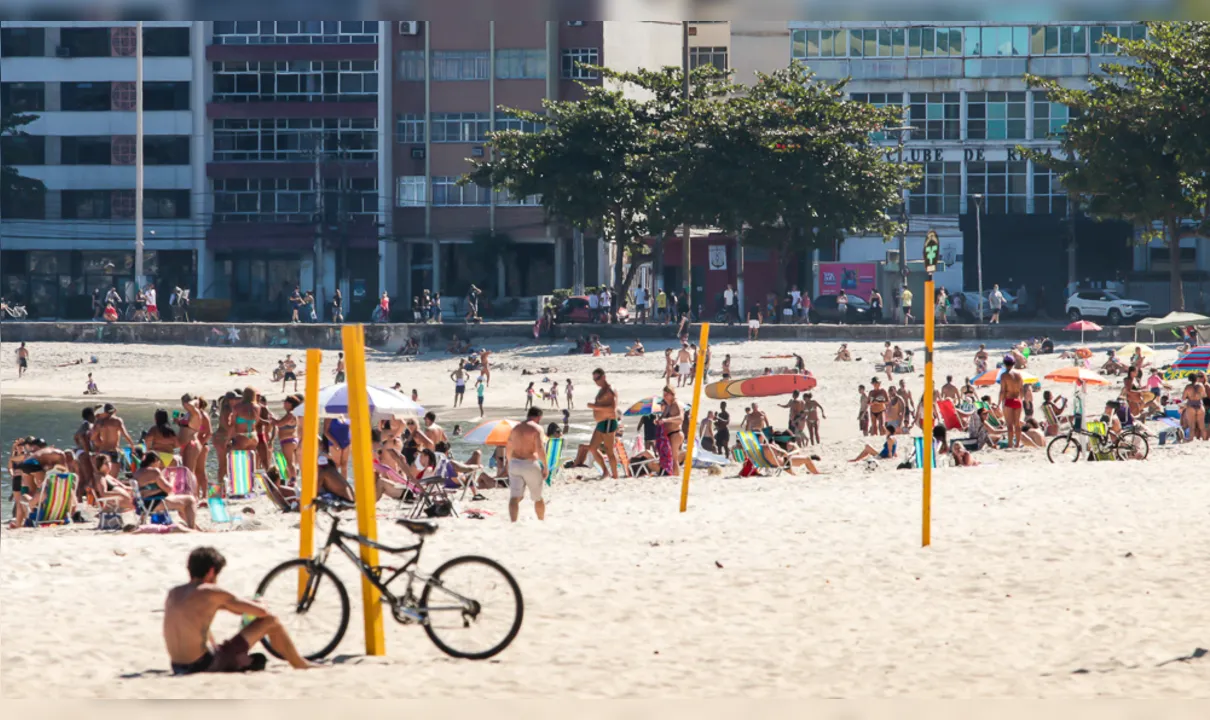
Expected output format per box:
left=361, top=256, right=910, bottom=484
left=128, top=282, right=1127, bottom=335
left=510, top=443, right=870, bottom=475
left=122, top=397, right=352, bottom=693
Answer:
left=417, top=555, right=525, bottom=659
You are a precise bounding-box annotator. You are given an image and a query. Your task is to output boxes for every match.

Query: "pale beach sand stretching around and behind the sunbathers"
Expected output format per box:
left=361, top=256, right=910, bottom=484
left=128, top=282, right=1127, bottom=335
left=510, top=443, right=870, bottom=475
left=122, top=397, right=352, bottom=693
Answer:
left=0, top=333, right=1210, bottom=698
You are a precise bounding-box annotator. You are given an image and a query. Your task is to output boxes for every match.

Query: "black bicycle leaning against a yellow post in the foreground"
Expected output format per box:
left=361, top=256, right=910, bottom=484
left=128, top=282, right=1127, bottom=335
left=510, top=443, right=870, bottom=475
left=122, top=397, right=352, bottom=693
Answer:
left=255, top=499, right=524, bottom=659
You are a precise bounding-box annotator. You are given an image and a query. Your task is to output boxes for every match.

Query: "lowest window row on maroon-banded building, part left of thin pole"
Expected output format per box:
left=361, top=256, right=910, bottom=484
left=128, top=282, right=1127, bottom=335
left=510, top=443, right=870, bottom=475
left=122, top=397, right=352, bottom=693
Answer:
left=214, top=178, right=316, bottom=223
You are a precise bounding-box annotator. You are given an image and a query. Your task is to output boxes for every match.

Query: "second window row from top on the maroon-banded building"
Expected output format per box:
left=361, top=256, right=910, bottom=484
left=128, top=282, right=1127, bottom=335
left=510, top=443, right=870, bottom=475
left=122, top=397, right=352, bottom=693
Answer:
left=214, top=61, right=378, bottom=103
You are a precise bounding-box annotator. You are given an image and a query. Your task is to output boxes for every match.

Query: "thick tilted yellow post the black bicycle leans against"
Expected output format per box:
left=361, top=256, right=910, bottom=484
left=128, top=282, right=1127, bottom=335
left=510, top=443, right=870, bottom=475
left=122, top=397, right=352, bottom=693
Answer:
left=341, top=326, right=386, bottom=655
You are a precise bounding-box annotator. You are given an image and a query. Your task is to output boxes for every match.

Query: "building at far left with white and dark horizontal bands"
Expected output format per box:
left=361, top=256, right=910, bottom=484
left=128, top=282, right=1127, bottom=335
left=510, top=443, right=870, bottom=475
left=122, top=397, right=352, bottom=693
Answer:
left=0, top=21, right=206, bottom=317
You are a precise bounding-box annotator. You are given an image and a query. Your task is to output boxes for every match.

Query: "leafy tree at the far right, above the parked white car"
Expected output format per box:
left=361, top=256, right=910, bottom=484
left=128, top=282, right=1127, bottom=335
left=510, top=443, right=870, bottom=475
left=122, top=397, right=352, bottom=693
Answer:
left=1026, top=23, right=1210, bottom=310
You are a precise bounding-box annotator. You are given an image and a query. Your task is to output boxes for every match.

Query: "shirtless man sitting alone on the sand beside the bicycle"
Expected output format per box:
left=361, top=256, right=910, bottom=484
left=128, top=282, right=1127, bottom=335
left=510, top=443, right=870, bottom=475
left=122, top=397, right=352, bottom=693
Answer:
left=163, top=547, right=318, bottom=675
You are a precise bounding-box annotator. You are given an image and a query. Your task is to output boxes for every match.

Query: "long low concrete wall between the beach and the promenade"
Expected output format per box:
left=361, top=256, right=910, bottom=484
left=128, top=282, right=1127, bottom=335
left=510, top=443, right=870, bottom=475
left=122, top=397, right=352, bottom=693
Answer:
left=4, top=322, right=1150, bottom=351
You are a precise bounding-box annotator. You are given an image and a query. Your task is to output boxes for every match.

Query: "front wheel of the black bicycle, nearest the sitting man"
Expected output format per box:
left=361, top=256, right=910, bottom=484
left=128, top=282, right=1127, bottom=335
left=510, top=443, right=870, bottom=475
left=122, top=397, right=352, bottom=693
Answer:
left=255, top=559, right=348, bottom=659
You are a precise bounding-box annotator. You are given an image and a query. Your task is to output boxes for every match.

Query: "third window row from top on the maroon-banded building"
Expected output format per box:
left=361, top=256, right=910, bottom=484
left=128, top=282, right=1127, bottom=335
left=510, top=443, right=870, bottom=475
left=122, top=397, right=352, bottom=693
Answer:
left=214, top=117, right=378, bottom=162
